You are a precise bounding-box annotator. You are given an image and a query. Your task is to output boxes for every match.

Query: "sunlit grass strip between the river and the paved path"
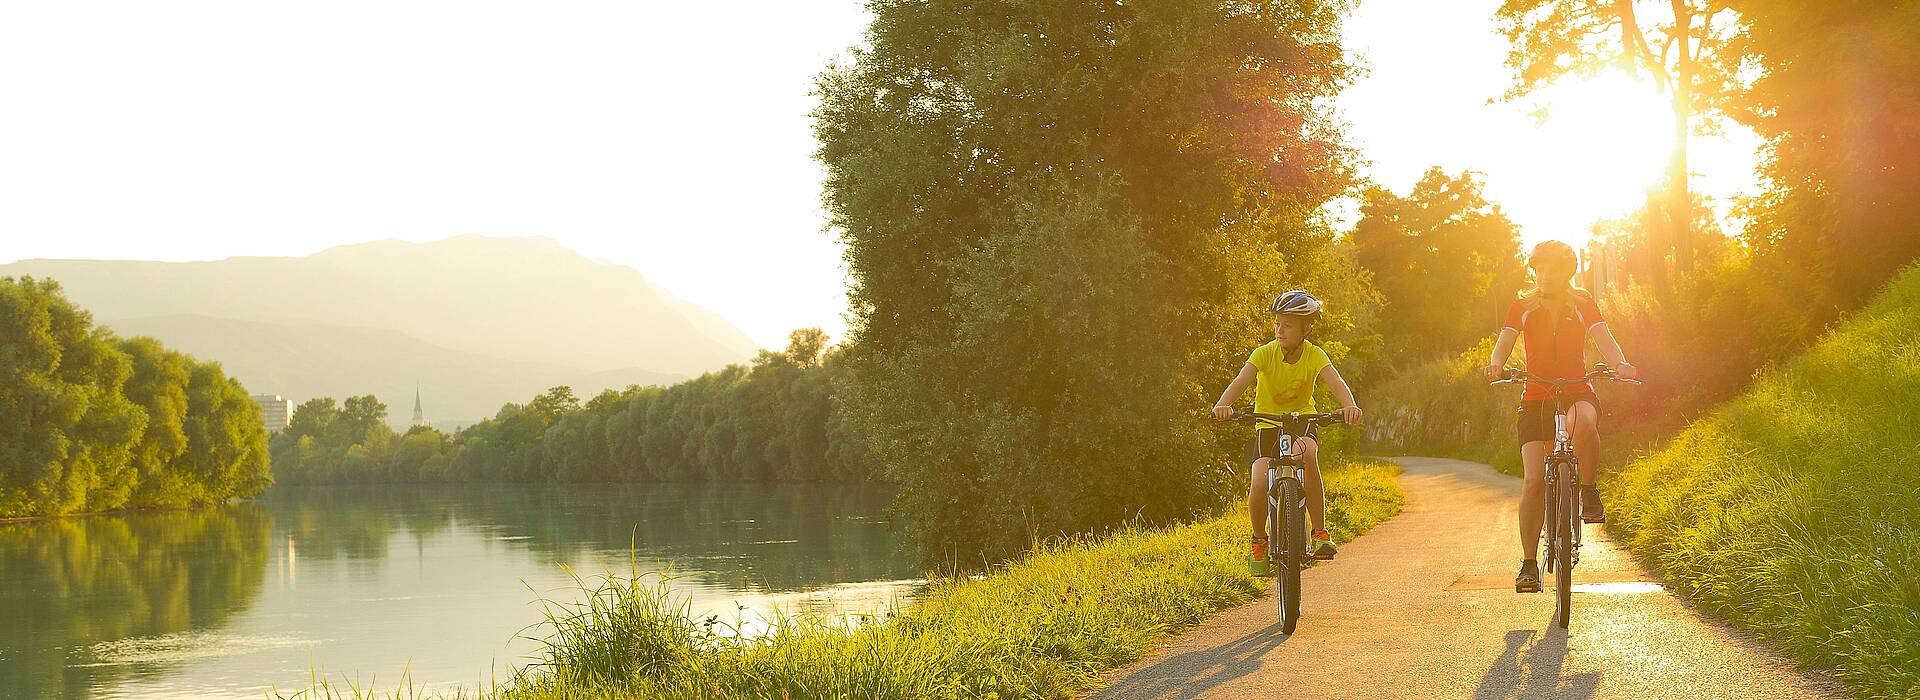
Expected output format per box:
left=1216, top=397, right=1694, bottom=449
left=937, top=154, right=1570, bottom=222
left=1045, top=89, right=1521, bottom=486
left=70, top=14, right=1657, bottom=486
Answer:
left=278, top=462, right=1402, bottom=700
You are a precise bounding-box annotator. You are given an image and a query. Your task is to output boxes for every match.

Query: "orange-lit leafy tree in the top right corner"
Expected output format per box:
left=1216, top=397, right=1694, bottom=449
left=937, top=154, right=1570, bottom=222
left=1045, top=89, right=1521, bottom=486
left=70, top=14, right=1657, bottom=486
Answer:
left=1730, top=0, right=1920, bottom=331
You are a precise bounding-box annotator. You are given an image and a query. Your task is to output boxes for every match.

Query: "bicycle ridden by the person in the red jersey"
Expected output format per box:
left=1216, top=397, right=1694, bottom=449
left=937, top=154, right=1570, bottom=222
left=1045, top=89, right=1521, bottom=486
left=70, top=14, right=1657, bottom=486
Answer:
left=1488, top=362, right=1642, bottom=629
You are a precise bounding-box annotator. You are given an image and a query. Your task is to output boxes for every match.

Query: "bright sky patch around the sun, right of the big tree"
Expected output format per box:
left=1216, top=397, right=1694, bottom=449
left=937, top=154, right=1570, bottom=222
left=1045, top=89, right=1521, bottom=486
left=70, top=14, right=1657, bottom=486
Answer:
left=1338, top=0, right=1759, bottom=247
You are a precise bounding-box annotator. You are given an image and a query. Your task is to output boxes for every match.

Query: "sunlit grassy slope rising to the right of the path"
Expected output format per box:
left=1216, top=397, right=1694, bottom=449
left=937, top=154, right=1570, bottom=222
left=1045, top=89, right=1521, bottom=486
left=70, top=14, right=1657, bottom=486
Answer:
left=1605, top=262, right=1920, bottom=698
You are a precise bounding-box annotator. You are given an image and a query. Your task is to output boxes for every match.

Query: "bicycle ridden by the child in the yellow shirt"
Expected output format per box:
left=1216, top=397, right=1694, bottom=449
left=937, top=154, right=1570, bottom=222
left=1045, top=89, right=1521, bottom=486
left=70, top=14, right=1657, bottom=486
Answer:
left=1233, top=410, right=1342, bottom=635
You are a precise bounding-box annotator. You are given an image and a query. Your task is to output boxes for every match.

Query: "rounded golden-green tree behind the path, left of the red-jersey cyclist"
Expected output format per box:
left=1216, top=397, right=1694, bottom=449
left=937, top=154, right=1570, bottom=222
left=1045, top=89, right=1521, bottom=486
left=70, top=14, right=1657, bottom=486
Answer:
left=1352, top=167, right=1524, bottom=364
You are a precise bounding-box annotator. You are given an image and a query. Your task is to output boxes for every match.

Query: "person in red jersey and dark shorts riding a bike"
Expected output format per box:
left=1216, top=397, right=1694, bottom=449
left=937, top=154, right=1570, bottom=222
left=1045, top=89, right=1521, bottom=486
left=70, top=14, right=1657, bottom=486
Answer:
left=1484, top=240, right=1640, bottom=593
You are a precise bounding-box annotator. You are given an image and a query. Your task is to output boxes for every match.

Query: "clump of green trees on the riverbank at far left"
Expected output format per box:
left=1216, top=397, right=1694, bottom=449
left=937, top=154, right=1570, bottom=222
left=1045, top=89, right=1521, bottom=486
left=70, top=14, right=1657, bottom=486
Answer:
left=0, top=278, right=271, bottom=518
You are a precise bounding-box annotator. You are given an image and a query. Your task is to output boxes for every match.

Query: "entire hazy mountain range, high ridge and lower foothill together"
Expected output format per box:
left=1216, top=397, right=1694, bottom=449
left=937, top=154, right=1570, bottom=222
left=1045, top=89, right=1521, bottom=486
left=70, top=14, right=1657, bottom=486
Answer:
left=0, top=236, right=758, bottom=422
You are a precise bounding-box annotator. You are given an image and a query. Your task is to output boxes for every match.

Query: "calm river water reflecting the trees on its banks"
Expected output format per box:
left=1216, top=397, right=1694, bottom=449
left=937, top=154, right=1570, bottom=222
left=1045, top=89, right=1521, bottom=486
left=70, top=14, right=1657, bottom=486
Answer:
left=0, top=483, right=920, bottom=698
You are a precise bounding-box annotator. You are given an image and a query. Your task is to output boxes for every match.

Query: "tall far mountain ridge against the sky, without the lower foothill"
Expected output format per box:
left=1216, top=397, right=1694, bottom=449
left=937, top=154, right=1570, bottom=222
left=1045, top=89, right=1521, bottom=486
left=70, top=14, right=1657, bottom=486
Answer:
left=0, top=236, right=758, bottom=374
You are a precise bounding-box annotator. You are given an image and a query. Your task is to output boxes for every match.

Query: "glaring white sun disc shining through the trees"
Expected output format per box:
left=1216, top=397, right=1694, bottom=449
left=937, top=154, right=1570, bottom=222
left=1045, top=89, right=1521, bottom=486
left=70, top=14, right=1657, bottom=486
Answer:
left=1488, top=71, right=1674, bottom=247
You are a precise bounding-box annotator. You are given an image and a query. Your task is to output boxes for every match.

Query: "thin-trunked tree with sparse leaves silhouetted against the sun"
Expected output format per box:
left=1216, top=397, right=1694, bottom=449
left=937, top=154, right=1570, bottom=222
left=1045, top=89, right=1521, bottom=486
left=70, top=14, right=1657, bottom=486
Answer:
left=1496, top=0, right=1738, bottom=289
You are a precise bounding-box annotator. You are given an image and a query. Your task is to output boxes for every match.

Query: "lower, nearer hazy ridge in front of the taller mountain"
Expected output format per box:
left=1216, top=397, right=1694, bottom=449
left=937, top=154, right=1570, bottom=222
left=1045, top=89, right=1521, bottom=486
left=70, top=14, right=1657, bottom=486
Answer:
left=108, top=316, right=685, bottom=426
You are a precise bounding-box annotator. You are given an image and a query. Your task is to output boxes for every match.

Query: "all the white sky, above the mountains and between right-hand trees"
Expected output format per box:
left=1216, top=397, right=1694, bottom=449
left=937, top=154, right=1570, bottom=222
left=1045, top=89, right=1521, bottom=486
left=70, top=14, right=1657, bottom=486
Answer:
left=0, top=0, right=1753, bottom=347
